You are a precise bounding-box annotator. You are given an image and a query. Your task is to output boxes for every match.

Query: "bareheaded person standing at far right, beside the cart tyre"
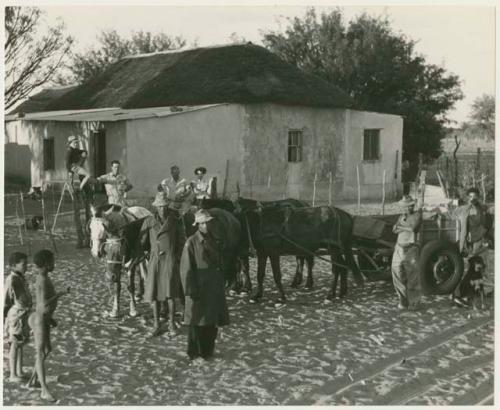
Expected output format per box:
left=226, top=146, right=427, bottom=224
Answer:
left=452, top=188, right=488, bottom=306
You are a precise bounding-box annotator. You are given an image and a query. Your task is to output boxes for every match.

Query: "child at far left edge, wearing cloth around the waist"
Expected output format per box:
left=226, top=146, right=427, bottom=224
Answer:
left=3, top=252, right=32, bottom=382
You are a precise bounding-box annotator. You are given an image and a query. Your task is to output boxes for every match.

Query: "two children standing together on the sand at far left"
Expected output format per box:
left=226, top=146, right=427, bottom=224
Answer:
left=3, top=250, right=70, bottom=401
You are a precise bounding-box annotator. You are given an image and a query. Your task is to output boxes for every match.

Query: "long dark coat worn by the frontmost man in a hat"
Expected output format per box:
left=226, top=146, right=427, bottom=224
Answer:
left=181, top=231, right=229, bottom=326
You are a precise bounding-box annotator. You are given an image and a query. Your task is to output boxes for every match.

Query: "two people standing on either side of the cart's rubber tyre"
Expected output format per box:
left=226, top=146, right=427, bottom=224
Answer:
left=391, top=188, right=488, bottom=311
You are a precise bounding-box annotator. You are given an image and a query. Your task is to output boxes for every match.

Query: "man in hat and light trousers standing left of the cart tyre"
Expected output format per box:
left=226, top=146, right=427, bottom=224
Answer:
left=391, top=196, right=422, bottom=310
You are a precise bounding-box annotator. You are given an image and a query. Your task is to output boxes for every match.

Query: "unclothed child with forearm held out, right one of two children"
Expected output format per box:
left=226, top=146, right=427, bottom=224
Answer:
left=28, top=250, right=70, bottom=401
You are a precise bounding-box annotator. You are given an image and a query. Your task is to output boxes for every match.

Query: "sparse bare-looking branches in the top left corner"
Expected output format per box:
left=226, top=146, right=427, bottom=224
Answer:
left=5, top=7, right=73, bottom=110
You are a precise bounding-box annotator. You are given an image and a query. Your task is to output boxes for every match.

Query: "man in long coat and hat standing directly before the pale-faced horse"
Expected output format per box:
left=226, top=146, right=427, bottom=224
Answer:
left=142, top=192, right=185, bottom=336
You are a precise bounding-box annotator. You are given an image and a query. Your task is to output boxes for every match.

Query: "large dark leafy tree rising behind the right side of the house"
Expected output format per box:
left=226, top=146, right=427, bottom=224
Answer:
left=262, top=8, right=463, bottom=164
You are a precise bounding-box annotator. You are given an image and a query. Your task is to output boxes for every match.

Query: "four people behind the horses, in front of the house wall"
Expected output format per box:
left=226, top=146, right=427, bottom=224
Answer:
left=66, top=135, right=212, bottom=207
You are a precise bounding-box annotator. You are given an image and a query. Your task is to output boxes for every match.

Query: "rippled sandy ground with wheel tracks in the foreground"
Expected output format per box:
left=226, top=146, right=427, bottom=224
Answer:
left=3, top=205, right=494, bottom=405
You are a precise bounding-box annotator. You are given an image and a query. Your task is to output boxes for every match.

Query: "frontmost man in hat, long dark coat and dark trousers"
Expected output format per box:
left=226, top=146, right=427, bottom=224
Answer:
left=181, top=209, right=229, bottom=360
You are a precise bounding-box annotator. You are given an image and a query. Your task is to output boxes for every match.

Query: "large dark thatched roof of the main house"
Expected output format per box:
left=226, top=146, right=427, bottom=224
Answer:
left=47, top=44, right=350, bottom=110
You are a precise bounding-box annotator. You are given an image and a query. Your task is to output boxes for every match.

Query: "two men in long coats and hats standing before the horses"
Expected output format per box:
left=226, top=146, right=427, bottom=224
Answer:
left=142, top=191, right=229, bottom=360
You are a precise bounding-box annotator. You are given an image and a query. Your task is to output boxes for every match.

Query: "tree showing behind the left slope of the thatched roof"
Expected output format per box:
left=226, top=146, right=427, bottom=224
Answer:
left=58, top=30, right=186, bottom=84
